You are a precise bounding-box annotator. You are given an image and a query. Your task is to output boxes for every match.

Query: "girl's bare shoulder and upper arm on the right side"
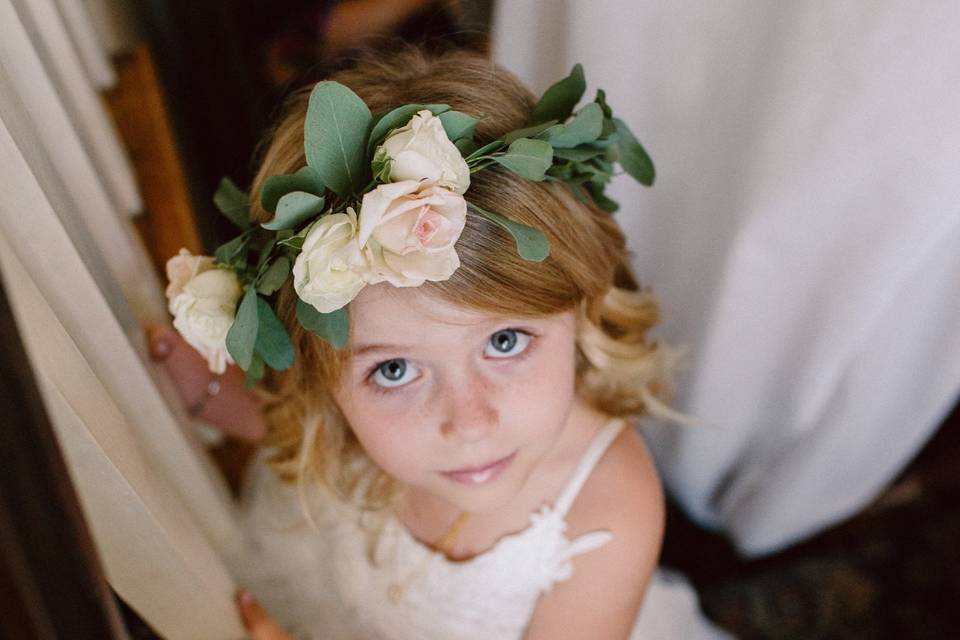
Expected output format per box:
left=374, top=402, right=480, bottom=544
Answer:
left=526, top=429, right=664, bottom=640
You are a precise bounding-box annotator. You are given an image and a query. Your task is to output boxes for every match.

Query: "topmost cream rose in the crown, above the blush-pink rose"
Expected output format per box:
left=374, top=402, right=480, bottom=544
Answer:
left=382, top=109, right=470, bottom=194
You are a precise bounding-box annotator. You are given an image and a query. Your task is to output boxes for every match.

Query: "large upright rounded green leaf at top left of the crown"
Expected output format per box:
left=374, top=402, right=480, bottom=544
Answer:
left=303, top=80, right=371, bottom=196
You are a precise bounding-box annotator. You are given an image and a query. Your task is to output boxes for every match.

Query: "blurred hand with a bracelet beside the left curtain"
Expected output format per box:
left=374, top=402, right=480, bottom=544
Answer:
left=147, top=325, right=266, bottom=442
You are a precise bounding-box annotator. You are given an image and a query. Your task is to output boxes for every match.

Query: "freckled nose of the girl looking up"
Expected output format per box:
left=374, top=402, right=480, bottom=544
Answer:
left=440, top=376, right=500, bottom=442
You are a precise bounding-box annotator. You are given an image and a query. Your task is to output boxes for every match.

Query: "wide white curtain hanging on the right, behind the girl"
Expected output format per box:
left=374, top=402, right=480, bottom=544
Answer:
left=494, top=0, right=960, bottom=555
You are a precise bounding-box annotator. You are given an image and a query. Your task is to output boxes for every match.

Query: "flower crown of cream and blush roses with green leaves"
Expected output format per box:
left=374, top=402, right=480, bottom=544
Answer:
left=167, top=64, right=654, bottom=384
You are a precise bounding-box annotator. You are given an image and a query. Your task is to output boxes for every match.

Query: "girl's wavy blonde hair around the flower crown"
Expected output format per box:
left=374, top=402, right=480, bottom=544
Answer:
left=251, top=49, right=671, bottom=509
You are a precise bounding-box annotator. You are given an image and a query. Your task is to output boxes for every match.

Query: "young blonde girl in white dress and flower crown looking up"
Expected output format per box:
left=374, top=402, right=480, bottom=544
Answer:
left=165, top=46, right=732, bottom=640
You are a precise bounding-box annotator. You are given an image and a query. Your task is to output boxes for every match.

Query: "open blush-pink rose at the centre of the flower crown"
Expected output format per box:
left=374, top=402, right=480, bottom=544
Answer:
left=358, top=180, right=467, bottom=287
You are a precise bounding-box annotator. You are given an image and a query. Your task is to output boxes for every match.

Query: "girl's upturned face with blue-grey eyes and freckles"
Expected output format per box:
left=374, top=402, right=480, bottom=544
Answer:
left=334, top=285, right=576, bottom=513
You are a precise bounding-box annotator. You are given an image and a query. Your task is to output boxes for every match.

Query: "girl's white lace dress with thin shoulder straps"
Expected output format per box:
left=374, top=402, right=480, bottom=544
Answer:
left=235, top=420, right=729, bottom=640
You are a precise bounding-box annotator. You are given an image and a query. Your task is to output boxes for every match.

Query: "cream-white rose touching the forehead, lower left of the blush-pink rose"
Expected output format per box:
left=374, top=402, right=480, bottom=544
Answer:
left=293, top=208, right=367, bottom=313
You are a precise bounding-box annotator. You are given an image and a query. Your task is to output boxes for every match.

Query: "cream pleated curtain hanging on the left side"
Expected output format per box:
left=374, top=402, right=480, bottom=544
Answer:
left=0, top=0, right=243, bottom=640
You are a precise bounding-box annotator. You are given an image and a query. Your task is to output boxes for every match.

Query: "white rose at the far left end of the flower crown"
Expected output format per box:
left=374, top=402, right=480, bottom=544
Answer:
left=170, top=266, right=243, bottom=373
